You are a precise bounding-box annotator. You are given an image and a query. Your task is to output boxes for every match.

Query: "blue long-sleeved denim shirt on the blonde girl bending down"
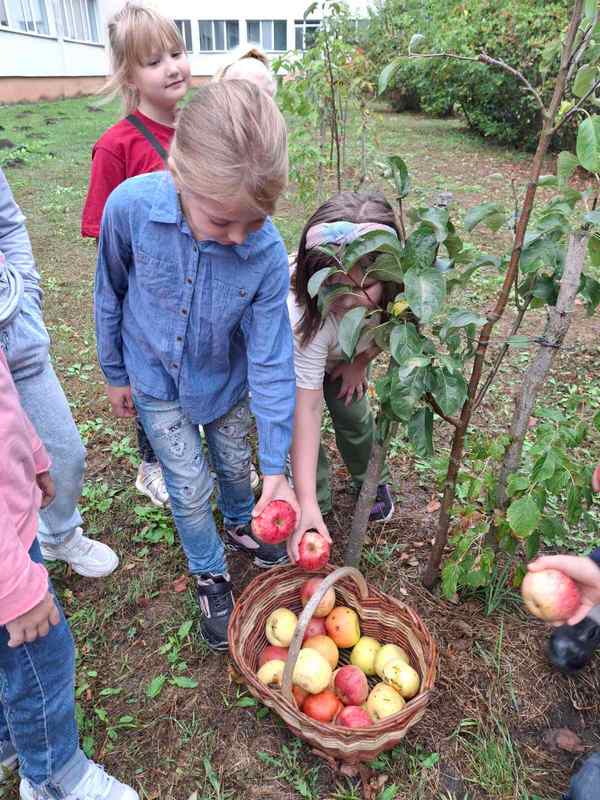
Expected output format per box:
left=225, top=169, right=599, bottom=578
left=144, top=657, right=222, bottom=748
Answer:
left=94, top=172, right=295, bottom=475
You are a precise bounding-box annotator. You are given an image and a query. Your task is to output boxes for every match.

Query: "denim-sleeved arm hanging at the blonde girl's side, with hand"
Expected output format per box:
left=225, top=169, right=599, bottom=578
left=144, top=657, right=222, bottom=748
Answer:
left=94, top=184, right=135, bottom=417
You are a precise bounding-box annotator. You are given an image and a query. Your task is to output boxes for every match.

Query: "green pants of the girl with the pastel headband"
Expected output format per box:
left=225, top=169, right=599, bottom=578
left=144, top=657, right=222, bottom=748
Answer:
left=317, top=375, right=390, bottom=514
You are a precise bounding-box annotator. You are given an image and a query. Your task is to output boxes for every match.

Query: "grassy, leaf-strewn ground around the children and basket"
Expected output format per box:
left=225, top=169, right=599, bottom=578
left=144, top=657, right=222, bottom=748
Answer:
left=0, top=98, right=600, bottom=800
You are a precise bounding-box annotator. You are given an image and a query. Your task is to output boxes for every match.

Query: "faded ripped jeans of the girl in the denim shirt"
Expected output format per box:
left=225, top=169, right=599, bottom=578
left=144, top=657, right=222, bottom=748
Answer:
left=133, top=390, right=254, bottom=575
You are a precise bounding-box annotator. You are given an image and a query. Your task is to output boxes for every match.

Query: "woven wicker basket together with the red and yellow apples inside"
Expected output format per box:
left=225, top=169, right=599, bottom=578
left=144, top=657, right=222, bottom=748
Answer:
left=229, top=564, right=437, bottom=764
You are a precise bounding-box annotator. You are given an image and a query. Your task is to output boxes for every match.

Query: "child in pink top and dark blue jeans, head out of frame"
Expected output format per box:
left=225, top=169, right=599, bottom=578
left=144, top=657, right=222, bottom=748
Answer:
left=0, top=350, right=138, bottom=800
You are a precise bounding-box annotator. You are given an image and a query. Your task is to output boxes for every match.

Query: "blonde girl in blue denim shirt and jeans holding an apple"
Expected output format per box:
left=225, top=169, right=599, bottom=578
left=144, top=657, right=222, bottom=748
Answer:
left=95, top=80, right=297, bottom=649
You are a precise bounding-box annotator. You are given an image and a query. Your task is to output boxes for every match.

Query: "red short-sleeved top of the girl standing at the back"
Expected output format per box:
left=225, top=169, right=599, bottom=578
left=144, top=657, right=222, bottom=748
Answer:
left=81, top=111, right=175, bottom=239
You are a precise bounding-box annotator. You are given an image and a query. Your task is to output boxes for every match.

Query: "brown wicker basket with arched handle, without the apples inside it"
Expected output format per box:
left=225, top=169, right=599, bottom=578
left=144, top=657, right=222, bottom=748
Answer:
left=229, top=565, right=437, bottom=765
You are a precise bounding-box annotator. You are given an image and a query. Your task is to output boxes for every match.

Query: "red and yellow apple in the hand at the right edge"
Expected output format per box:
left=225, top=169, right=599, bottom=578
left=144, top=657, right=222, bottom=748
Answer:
left=521, top=569, right=581, bottom=622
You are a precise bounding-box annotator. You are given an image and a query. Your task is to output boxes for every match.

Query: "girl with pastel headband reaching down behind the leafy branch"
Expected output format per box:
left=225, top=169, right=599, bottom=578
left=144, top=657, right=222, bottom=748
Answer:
left=288, top=192, right=398, bottom=559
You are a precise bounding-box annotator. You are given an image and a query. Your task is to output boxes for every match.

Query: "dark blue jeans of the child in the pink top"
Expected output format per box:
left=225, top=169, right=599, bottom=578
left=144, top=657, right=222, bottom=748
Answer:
left=0, top=540, right=88, bottom=798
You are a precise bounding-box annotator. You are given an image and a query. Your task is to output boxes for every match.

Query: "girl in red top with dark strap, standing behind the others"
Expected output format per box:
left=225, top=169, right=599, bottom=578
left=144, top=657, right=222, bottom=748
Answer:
left=81, top=3, right=190, bottom=507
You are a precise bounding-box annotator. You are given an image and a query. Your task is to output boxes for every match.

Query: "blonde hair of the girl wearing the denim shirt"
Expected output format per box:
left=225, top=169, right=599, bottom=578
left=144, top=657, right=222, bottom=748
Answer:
left=170, top=80, right=288, bottom=214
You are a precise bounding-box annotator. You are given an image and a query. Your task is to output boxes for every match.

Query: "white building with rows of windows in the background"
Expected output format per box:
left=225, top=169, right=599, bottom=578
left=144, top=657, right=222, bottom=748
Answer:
left=0, top=0, right=367, bottom=103
